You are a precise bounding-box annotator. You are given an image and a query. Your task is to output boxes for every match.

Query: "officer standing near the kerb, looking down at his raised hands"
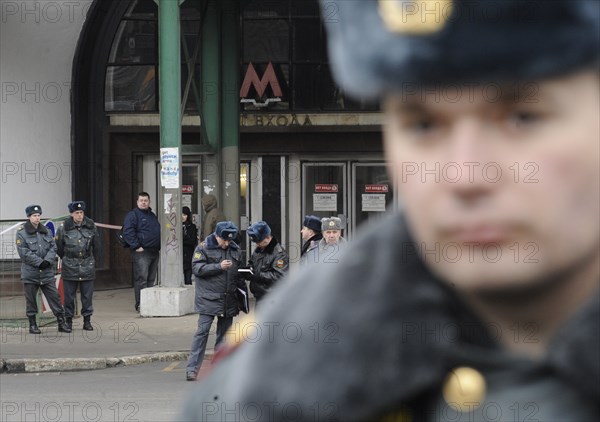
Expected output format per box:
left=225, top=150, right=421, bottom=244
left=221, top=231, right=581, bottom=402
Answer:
left=186, top=221, right=246, bottom=381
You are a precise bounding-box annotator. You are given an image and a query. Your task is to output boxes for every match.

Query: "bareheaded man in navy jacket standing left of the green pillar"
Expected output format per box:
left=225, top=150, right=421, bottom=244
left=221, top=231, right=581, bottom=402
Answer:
left=123, top=192, right=160, bottom=311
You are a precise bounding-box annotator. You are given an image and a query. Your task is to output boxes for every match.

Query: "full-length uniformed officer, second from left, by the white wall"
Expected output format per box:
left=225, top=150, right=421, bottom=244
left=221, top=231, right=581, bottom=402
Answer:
left=56, top=201, right=100, bottom=331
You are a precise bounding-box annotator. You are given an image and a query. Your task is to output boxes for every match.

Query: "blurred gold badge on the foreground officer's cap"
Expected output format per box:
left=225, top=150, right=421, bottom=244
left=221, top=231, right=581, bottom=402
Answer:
left=379, top=0, right=454, bottom=35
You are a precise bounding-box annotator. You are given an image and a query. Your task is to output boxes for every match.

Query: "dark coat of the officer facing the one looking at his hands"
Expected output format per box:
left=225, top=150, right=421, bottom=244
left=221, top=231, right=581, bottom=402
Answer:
left=248, top=236, right=290, bottom=299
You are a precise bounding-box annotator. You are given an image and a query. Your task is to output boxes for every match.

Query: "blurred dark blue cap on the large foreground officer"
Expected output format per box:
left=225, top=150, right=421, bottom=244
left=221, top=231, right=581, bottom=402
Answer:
left=320, top=0, right=600, bottom=99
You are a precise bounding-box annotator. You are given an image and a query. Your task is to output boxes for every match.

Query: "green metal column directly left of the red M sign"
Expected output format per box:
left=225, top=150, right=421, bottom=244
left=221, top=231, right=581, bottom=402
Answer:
left=221, top=0, right=240, bottom=226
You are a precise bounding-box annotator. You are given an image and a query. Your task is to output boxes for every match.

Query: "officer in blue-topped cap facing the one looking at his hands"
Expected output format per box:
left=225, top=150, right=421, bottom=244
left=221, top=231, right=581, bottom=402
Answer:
left=244, top=221, right=290, bottom=305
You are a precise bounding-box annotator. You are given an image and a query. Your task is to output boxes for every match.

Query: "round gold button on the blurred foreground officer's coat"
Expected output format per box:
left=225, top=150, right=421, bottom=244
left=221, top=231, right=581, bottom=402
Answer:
left=443, top=366, right=486, bottom=412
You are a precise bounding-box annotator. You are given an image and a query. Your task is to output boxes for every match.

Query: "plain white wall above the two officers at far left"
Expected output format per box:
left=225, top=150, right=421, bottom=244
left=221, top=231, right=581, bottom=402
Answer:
left=0, top=0, right=92, bottom=220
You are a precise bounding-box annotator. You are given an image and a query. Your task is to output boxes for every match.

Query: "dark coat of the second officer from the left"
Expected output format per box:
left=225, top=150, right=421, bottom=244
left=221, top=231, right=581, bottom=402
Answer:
left=56, top=217, right=100, bottom=281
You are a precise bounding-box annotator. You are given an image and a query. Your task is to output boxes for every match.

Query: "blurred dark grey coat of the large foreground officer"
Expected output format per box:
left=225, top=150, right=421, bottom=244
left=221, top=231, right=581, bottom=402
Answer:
left=182, top=215, right=600, bottom=421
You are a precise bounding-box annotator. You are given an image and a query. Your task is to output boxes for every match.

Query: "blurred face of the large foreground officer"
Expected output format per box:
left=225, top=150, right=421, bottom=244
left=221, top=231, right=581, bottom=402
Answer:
left=384, top=71, right=600, bottom=291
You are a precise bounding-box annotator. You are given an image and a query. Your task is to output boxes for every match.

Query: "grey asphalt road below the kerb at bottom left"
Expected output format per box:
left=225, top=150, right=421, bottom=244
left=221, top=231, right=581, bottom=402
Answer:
left=0, top=362, right=200, bottom=422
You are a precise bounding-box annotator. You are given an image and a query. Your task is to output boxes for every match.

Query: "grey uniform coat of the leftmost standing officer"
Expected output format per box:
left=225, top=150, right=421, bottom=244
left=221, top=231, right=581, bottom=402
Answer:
left=16, top=221, right=56, bottom=284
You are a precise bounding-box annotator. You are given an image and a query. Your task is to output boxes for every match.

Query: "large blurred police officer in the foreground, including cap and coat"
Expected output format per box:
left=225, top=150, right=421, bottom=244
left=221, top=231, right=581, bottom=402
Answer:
left=184, top=0, right=600, bottom=421
